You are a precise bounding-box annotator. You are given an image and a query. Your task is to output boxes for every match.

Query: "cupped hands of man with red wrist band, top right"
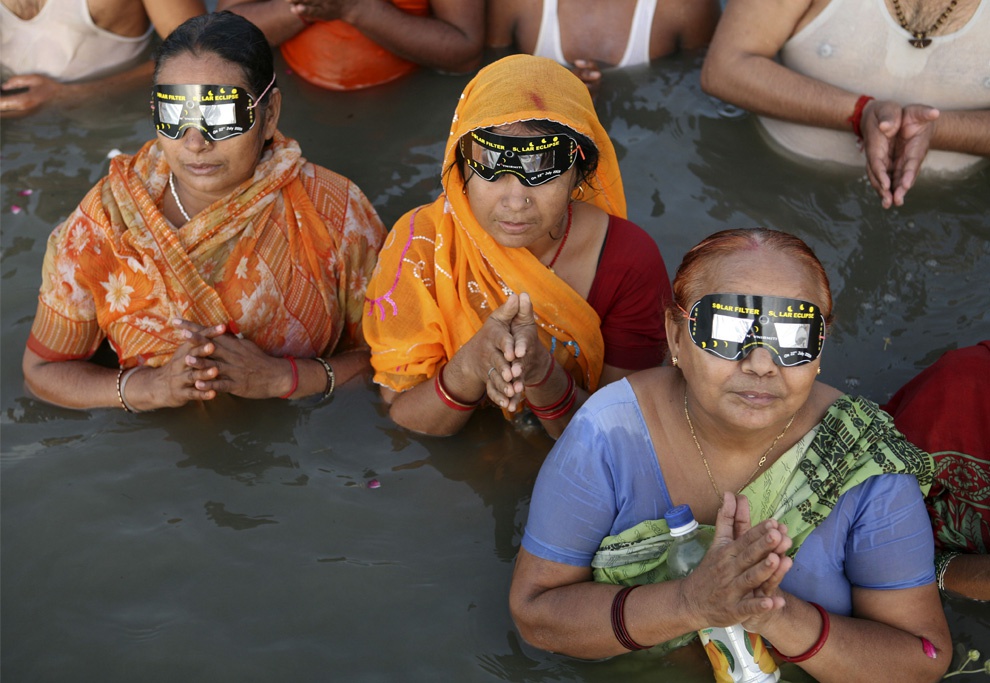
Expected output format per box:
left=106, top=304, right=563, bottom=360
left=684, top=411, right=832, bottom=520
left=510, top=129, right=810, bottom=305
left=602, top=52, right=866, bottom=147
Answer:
left=860, top=100, right=939, bottom=209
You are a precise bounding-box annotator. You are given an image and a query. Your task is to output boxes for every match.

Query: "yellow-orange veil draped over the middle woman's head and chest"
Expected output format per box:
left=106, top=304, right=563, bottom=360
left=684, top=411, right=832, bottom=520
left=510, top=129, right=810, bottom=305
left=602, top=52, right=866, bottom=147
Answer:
left=364, top=55, right=626, bottom=406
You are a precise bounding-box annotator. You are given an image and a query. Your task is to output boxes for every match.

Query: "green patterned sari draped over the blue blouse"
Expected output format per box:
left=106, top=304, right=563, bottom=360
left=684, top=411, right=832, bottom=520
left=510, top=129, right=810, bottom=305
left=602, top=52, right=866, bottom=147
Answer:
left=591, top=396, right=934, bottom=651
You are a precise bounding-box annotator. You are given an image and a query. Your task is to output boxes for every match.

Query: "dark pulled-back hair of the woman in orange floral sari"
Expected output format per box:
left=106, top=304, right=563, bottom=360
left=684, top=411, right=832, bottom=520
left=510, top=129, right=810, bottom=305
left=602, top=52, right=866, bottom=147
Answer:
left=155, top=11, right=277, bottom=114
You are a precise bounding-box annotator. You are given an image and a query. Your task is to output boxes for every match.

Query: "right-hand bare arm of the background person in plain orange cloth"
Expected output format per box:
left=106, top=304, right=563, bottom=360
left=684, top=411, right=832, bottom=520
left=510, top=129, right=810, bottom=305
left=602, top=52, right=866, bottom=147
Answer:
left=287, top=0, right=485, bottom=73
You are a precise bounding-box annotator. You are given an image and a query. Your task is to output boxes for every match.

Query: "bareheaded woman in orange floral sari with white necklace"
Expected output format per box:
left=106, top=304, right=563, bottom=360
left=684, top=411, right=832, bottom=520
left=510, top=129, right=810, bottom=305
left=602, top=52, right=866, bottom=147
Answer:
left=23, top=12, right=384, bottom=412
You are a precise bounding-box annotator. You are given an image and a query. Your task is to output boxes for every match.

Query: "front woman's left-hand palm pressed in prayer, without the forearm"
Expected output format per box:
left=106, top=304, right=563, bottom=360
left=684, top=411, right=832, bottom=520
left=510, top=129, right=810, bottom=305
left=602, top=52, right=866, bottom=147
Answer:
left=681, top=493, right=791, bottom=632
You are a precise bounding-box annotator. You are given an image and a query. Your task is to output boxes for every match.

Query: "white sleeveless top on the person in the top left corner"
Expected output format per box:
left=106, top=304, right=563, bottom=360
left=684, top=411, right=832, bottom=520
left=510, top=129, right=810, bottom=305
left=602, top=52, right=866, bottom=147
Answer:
left=0, top=0, right=154, bottom=82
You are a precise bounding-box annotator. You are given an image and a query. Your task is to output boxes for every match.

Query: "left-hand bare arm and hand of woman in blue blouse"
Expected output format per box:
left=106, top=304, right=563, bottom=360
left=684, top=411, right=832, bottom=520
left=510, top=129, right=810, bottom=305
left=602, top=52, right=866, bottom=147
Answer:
left=509, top=494, right=790, bottom=659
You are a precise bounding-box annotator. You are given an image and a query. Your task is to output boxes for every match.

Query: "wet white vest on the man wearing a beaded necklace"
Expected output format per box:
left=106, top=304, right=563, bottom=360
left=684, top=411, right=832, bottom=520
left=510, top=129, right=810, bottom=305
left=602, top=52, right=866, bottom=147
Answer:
left=760, top=0, right=990, bottom=175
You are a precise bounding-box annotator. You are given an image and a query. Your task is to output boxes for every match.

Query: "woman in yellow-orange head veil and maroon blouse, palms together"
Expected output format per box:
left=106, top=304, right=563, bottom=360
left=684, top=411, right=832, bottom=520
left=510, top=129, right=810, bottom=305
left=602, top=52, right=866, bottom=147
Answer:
left=364, top=55, right=670, bottom=436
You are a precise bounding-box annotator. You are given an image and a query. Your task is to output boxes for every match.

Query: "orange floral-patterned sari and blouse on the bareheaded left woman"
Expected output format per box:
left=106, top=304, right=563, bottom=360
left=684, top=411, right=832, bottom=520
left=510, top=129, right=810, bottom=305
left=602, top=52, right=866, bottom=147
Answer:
left=28, top=133, right=385, bottom=367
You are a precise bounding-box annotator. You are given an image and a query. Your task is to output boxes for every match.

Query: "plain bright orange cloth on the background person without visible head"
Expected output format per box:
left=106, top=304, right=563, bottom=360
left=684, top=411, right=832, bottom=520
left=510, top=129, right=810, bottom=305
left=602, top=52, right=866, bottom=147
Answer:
left=282, top=0, right=430, bottom=90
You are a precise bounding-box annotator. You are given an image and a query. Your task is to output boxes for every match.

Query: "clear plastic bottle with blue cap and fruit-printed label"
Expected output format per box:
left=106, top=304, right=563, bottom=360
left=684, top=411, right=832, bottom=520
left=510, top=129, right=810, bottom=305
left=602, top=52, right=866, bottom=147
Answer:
left=664, top=505, right=780, bottom=683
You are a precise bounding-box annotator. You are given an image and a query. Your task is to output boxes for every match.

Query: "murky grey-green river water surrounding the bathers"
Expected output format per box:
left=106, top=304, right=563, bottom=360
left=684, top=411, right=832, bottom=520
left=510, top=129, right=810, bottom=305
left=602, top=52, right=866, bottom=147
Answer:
left=0, top=40, right=990, bottom=683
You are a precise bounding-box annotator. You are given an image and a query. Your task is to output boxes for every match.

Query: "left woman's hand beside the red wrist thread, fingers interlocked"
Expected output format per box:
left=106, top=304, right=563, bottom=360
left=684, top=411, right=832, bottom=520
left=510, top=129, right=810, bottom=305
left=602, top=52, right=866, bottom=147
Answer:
left=174, top=320, right=292, bottom=398
